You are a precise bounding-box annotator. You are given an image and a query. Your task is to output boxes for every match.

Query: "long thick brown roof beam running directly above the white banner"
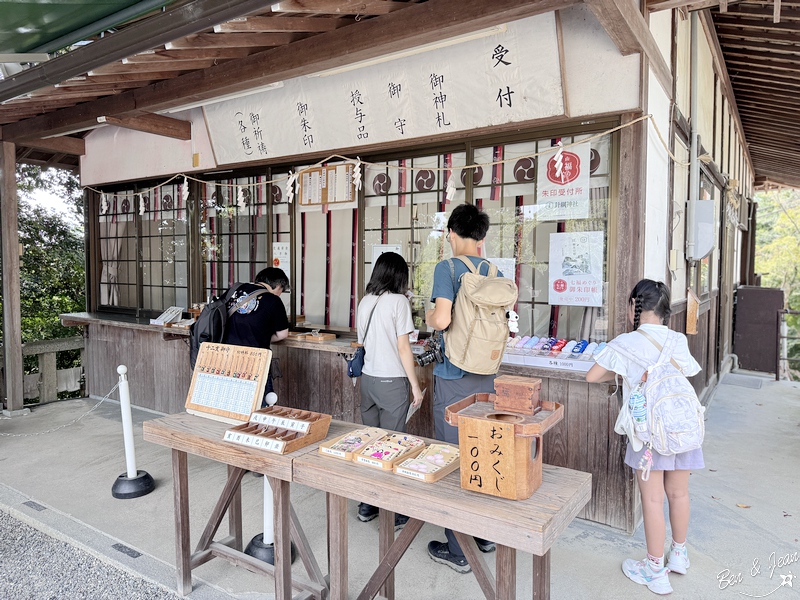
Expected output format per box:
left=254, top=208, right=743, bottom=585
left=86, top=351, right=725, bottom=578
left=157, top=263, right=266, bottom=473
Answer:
left=3, top=0, right=578, bottom=139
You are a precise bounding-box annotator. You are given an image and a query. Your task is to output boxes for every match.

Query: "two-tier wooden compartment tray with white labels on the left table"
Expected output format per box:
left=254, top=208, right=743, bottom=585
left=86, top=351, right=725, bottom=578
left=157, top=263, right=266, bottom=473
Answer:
left=222, top=406, right=331, bottom=454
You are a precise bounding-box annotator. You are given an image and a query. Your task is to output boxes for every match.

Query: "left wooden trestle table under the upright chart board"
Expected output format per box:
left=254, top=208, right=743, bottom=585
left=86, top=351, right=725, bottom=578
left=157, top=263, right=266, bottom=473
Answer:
left=144, top=413, right=354, bottom=600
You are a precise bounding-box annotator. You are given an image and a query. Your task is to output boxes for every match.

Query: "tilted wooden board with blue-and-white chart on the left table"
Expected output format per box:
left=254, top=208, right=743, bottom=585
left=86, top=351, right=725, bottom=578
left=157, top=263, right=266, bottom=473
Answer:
left=186, top=342, right=272, bottom=424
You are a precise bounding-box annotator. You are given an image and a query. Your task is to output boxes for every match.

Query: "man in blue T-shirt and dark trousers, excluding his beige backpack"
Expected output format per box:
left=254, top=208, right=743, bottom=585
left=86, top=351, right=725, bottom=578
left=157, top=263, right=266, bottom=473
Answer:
left=425, top=204, right=516, bottom=573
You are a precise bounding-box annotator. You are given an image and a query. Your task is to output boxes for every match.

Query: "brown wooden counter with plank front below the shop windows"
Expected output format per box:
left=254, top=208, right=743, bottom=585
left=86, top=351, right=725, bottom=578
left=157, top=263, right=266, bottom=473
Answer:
left=61, top=313, right=641, bottom=533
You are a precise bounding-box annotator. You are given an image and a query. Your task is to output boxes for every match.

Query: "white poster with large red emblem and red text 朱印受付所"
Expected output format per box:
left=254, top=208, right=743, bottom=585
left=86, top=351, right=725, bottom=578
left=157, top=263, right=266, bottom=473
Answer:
left=529, top=142, right=592, bottom=221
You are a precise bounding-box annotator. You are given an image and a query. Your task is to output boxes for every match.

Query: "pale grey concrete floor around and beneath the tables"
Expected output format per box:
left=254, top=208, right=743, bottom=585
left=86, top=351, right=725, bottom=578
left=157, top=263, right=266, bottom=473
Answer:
left=0, top=371, right=800, bottom=600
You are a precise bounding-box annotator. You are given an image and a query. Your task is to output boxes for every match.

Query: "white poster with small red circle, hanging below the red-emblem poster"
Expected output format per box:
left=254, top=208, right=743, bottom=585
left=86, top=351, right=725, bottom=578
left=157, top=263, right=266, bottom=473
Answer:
left=547, top=231, right=605, bottom=306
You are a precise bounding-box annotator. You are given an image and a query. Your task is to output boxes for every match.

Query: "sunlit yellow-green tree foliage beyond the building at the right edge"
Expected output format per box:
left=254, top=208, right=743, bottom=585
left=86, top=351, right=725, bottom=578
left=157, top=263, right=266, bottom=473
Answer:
left=755, top=189, right=800, bottom=373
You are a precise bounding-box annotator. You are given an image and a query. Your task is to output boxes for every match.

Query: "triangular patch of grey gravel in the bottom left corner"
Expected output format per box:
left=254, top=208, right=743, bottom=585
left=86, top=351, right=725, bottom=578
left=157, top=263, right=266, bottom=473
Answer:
left=0, top=511, right=181, bottom=600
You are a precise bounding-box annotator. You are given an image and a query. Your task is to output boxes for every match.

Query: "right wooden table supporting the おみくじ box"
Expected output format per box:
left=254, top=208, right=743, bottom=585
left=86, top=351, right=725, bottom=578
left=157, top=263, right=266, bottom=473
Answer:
left=292, top=440, right=592, bottom=600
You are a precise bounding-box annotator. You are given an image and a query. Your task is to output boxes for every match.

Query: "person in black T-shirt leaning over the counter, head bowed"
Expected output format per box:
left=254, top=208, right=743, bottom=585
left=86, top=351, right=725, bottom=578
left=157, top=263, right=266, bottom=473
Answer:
left=222, top=267, right=289, bottom=408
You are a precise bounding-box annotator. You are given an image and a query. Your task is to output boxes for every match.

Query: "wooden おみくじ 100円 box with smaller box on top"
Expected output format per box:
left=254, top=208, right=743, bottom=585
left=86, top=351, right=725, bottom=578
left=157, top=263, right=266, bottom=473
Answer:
left=445, top=375, right=564, bottom=500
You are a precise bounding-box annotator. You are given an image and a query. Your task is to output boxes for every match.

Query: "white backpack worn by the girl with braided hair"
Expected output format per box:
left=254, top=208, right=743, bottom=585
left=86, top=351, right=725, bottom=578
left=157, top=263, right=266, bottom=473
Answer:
left=609, top=329, right=705, bottom=456
